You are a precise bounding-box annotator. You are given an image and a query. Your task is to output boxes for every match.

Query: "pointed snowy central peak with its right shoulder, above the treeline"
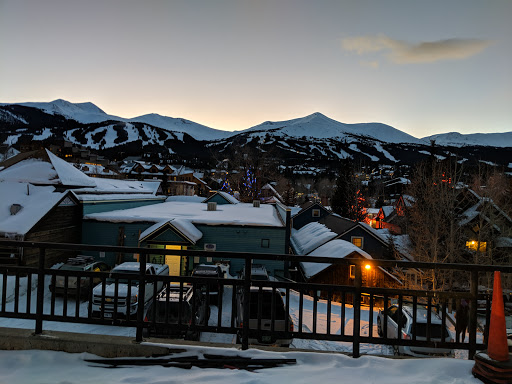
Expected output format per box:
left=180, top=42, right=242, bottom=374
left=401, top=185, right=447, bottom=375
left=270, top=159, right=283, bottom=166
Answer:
left=242, top=112, right=420, bottom=144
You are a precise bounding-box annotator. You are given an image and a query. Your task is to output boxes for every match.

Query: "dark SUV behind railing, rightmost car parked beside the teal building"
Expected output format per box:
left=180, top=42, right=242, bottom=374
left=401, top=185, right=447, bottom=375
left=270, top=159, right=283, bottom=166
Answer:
left=235, top=287, right=293, bottom=347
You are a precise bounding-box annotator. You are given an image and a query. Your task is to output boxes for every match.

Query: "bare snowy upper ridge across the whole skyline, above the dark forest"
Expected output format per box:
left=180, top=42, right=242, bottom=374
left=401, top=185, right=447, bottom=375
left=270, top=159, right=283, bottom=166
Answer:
left=0, top=99, right=512, bottom=147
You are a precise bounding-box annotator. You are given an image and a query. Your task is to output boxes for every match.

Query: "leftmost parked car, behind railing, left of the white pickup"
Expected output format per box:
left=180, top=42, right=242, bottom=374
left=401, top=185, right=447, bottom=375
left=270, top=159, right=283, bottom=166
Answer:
left=49, top=256, right=110, bottom=296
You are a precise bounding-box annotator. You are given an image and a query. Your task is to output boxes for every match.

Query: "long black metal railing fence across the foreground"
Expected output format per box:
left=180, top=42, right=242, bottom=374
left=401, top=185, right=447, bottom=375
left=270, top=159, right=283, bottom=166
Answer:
left=0, top=240, right=512, bottom=358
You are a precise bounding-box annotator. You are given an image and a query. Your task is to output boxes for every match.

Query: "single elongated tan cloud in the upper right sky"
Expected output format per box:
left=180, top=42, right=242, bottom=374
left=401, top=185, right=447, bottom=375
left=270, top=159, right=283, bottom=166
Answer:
left=342, top=35, right=492, bottom=64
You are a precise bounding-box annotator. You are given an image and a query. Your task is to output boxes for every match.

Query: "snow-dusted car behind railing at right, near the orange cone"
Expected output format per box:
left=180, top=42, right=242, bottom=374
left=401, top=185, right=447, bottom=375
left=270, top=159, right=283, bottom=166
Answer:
left=377, top=304, right=453, bottom=357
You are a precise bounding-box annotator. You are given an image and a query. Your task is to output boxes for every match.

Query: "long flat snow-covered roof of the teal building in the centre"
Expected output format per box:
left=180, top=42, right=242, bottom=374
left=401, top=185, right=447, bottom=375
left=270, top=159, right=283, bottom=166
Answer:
left=84, top=201, right=283, bottom=227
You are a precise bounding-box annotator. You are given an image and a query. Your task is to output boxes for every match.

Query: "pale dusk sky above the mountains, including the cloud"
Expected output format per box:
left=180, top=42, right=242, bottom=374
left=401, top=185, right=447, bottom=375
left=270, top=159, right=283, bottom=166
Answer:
left=0, top=0, right=512, bottom=137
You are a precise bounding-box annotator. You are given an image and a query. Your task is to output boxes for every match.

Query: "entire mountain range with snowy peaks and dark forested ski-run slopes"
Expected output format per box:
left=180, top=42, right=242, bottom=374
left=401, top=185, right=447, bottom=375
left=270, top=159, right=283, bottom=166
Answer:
left=0, top=99, right=512, bottom=171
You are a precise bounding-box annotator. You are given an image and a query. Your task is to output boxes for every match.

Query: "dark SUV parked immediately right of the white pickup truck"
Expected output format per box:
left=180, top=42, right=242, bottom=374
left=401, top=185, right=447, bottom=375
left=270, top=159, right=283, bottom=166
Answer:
left=144, top=284, right=210, bottom=340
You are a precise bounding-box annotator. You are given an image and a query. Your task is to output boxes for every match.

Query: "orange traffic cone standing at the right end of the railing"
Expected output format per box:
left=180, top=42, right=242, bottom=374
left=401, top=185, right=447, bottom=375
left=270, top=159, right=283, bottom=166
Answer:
left=487, top=271, right=509, bottom=361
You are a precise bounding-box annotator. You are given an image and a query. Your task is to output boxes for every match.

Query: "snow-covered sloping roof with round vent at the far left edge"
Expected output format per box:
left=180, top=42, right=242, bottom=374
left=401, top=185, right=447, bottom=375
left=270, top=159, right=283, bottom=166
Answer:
left=0, top=181, right=68, bottom=235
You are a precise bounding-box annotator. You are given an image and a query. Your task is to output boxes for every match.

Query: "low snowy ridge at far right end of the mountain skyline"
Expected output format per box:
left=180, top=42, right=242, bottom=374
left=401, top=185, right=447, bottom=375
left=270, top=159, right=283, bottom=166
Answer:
left=422, top=132, right=512, bottom=147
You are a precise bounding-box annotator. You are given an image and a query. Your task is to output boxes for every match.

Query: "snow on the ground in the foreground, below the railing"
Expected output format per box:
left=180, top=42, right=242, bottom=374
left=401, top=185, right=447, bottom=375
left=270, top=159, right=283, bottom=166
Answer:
left=0, top=346, right=480, bottom=384
